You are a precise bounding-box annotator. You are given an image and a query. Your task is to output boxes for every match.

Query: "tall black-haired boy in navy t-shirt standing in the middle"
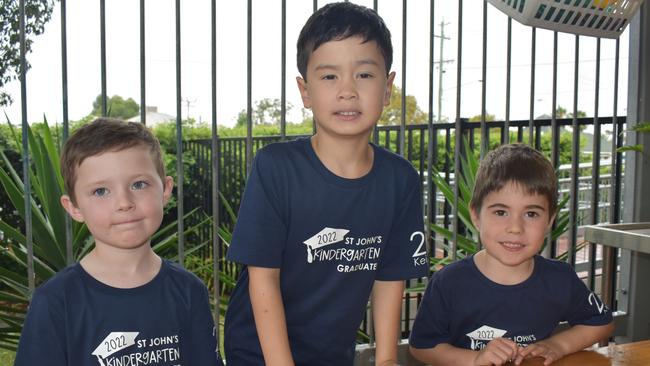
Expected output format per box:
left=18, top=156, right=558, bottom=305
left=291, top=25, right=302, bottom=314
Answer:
left=224, top=3, right=428, bottom=366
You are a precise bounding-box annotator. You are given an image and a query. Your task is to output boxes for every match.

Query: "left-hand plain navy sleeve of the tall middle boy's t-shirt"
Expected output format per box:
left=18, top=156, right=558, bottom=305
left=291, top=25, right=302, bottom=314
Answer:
left=226, top=149, right=287, bottom=268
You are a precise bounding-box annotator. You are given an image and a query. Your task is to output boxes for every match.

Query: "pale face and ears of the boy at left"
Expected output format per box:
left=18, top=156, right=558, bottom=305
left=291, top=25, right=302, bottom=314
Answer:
left=61, top=146, right=173, bottom=249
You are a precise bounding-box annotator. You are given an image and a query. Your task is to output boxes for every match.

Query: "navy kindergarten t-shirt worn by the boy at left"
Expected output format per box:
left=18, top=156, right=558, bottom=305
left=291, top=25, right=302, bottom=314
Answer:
left=14, top=261, right=223, bottom=366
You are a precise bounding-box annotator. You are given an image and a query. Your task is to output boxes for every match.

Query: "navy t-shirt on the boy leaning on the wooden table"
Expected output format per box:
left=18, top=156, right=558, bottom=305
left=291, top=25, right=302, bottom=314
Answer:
left=409, top=256, right=612, bottom=351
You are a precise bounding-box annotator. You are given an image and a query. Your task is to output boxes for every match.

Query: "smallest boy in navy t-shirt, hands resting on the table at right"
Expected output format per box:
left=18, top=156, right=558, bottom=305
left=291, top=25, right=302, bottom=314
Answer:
left=410, top=144, right=614, bottom=365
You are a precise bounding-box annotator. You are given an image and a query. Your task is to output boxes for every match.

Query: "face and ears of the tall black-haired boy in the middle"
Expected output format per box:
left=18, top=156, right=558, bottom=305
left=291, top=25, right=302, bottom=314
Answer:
left=297, top=37, right=395, bottom=137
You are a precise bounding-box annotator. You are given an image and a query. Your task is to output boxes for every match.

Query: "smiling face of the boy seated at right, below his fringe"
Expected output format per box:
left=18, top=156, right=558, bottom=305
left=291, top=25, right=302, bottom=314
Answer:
left=472, top=182, right=552, bottom=268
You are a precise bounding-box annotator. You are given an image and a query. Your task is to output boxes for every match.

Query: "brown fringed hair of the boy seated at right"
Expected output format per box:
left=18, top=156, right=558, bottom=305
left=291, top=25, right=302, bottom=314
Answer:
left=470, top=144, right=558, bottom=217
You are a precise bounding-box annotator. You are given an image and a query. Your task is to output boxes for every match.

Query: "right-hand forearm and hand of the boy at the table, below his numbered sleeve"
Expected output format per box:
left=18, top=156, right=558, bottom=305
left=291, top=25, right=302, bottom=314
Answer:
left=515, top=322, right=614, bottom=365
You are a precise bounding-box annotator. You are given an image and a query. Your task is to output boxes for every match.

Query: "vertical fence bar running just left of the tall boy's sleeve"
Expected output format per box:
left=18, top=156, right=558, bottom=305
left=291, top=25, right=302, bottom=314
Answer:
left=210, top=0, right=221, bottom=347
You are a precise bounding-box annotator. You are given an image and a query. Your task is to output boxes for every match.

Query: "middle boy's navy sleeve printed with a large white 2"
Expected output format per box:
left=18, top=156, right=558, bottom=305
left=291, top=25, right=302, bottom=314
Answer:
left=377, top=169, right=429, bottom=281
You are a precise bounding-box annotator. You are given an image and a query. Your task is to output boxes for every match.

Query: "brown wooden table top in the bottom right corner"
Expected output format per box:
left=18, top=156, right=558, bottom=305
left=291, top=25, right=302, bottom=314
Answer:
left=521, top=340, right=650, bottom=366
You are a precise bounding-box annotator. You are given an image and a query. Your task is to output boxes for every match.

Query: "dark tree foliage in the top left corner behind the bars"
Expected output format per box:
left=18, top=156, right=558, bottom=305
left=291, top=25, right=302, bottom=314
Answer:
left=0, top=0, right=54, bottom=106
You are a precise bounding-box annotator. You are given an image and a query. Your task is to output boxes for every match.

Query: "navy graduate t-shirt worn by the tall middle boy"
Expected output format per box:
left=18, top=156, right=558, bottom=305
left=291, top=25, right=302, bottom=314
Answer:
left=225, top=139, right=429, bottom=366
